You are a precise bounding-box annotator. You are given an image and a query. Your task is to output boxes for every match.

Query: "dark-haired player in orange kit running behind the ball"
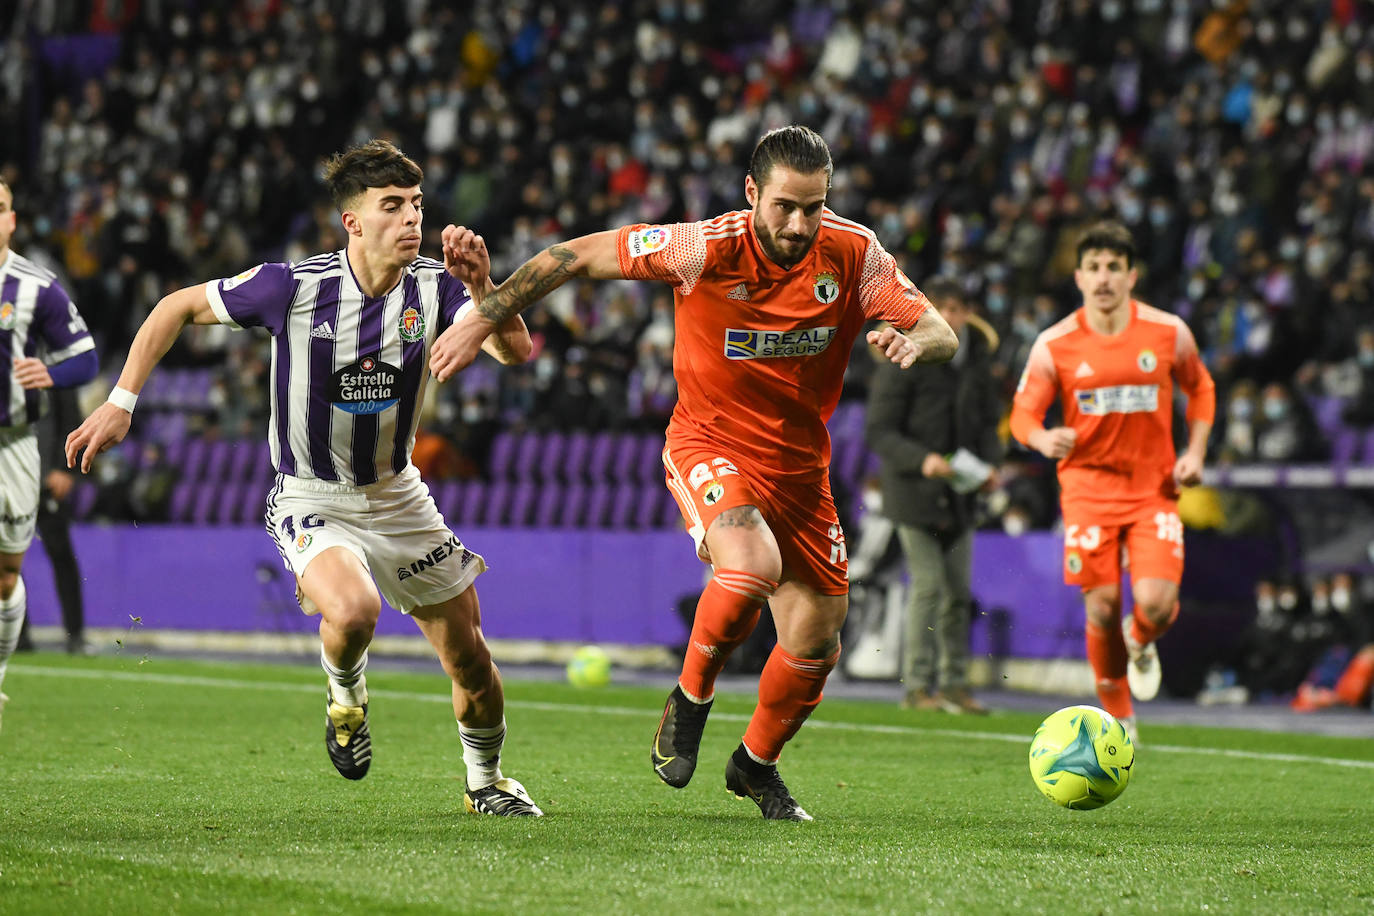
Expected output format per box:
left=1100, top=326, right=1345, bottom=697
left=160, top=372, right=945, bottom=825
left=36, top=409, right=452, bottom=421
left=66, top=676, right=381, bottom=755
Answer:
left=1011, top=222, right=1216, bottom=739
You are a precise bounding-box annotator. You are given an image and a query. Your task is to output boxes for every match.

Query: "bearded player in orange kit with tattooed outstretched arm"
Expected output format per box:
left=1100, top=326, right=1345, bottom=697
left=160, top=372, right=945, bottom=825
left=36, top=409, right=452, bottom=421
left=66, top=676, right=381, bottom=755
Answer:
left=431, top=126, right=958, bottom=820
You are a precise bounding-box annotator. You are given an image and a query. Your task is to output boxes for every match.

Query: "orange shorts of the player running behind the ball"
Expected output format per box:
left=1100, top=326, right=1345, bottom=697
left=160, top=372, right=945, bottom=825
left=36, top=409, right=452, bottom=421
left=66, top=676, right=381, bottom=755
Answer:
left=1063, top=500, right=1183, bottom=589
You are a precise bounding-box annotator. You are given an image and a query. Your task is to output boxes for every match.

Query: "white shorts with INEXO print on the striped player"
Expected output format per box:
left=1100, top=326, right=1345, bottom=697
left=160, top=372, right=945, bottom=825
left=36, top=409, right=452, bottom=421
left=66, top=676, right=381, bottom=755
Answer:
left=267, top=464, right=486, bottom=614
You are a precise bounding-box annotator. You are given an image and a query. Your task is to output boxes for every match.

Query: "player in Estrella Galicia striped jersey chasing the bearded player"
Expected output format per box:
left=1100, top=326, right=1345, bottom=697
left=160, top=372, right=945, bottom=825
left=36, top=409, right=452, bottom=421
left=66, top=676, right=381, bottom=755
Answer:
left=67, top=140, right=541, bottom=816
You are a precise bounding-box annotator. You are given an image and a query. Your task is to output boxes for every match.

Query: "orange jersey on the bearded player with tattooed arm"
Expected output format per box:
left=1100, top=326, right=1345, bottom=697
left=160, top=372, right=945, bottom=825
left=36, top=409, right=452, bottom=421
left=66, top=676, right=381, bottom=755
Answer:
left=616, top=209, right=929, bottom=477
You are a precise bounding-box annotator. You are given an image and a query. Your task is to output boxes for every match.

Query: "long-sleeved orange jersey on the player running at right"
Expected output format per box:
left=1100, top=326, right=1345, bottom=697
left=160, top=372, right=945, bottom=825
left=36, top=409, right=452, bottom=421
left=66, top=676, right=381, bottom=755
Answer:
left=1011, top=299, right=1216, bottom=514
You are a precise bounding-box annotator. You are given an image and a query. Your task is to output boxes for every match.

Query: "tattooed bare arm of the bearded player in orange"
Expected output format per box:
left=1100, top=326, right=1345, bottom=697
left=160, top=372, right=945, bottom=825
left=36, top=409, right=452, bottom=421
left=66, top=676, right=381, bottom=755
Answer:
left=430, top=229, right=625, bottom=382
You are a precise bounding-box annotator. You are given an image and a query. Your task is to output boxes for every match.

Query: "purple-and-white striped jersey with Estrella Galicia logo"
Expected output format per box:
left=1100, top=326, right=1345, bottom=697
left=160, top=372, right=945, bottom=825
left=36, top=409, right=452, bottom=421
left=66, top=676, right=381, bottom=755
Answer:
left=206, top=251, right=470, bottom=486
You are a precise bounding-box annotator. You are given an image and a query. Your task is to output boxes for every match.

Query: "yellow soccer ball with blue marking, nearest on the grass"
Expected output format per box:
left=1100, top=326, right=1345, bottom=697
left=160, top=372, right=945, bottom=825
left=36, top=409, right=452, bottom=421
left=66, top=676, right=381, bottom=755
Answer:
left=1031, top=706, right=1135, bottom=810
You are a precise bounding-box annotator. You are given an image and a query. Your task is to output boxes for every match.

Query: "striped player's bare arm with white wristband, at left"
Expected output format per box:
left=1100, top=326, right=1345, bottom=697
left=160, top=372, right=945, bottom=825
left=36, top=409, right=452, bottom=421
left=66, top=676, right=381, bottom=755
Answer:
left=66, top=283, right=218, bottom=474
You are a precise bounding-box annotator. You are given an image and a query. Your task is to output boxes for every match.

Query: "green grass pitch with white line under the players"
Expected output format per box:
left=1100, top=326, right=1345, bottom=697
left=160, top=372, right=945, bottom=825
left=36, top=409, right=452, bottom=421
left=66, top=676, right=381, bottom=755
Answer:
left=0, top=654, right=1374, bottom=916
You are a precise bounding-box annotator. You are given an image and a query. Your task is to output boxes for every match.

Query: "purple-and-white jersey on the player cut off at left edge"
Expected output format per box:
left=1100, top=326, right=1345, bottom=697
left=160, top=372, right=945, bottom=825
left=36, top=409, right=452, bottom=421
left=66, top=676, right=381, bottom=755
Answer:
left=0, top=251, right=95, bottom=427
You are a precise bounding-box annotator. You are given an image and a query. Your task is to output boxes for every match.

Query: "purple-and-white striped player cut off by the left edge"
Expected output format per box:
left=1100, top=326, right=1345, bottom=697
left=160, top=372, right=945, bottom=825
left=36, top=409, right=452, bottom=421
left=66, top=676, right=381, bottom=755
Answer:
left=0, top=179, right=99, bottom=713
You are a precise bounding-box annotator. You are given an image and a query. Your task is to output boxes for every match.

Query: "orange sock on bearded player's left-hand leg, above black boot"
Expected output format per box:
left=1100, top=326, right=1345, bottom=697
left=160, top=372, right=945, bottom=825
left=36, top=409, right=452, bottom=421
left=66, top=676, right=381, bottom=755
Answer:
left=677, top=569, right=778, bottom=702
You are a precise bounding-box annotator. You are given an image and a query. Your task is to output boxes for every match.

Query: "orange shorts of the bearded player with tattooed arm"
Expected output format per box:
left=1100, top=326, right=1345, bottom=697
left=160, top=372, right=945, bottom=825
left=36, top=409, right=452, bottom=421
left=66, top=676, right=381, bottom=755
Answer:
left=664, top=437, right=849, bottom=595
